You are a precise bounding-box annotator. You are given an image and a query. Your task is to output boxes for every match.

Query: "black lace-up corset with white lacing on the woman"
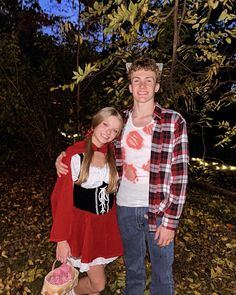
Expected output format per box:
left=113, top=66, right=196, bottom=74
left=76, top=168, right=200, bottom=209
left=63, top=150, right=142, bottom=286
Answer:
left=74, top=182, right=115, bottom=215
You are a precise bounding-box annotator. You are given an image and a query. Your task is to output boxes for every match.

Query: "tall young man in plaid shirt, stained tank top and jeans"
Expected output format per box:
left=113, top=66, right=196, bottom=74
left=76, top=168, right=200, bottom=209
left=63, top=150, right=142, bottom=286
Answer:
left=57, top=58, right=188, bottom=295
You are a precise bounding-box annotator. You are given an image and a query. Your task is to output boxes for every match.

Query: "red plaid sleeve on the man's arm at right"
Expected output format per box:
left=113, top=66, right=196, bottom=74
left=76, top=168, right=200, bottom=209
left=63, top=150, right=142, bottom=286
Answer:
left=162, top=117, right=189, bottom=230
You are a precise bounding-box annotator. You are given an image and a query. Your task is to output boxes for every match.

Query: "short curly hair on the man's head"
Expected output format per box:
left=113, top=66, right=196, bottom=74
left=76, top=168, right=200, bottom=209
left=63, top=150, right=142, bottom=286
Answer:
left=128, top=57, right=161, bottom=83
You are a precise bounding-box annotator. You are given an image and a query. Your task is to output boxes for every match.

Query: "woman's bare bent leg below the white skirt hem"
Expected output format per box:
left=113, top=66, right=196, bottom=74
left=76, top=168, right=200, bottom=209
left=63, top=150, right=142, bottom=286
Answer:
left=74, top=265, right=106, bottom=295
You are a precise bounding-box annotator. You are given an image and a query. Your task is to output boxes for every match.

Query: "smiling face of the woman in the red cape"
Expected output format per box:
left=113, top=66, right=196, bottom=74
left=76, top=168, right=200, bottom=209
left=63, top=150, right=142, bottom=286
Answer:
left=92, top=116, right=122, bottom=147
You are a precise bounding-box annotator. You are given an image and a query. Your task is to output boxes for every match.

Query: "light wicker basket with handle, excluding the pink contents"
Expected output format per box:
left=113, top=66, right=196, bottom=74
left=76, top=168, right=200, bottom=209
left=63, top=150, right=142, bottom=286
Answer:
left=41, top=260, right=79, bottom=295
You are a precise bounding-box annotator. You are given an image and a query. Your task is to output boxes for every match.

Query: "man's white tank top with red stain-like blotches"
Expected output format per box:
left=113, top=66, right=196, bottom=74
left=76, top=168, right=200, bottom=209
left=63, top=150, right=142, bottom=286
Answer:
left=117, top=115, right=154, bottom=207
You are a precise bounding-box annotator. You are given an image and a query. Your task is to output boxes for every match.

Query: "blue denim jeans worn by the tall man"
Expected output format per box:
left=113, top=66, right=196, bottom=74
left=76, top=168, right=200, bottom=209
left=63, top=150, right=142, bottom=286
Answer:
left=117, top=206, right=174, bottom=295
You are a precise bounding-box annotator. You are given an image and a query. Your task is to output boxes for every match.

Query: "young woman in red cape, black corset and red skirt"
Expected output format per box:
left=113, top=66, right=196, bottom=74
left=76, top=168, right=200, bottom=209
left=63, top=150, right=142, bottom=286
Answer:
left=50, top=107, right=123, bottom=295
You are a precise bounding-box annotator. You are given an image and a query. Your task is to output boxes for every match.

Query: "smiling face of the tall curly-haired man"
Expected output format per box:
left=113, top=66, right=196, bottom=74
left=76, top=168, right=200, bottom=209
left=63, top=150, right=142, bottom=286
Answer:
left=129, top=70, right=160, bottom=103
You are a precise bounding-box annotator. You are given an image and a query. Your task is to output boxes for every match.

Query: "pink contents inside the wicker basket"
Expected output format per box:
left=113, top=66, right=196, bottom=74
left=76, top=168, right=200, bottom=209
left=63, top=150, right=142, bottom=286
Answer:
left=48, top=263, right=73, bottom=285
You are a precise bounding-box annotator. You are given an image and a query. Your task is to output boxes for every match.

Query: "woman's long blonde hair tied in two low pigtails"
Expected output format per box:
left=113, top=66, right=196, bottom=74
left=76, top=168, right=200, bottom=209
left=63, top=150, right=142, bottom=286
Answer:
left=75, top=107, right=123, bottom=193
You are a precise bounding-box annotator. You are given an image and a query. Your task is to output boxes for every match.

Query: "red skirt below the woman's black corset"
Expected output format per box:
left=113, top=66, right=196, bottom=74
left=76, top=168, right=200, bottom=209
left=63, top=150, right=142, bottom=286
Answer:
left=68, top=204, right=123, bottom=263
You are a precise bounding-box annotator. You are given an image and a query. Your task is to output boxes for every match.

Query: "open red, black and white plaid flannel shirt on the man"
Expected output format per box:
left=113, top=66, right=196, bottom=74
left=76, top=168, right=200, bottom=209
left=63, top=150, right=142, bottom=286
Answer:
left=114, top=103, right=189, bottom=231
